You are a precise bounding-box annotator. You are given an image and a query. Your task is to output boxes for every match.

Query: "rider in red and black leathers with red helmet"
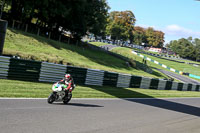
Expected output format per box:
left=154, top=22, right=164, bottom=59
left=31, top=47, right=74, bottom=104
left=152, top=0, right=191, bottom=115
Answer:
left=59, top=74, right=75, bottom=94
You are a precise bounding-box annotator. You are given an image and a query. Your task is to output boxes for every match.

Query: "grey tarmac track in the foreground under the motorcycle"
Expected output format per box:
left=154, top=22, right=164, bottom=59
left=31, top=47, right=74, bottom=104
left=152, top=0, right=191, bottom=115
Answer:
left=0, top=98, right=200, bottom=133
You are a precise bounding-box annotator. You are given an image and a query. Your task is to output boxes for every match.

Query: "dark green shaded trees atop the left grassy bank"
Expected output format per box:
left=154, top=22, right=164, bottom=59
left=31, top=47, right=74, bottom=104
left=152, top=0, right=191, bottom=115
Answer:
left=0, top=0, right=109, bottom=39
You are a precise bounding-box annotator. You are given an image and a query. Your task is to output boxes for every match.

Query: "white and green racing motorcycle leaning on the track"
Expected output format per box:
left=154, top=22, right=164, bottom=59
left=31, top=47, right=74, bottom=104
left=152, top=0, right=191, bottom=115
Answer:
left=47, top=83, right=72, bottom=104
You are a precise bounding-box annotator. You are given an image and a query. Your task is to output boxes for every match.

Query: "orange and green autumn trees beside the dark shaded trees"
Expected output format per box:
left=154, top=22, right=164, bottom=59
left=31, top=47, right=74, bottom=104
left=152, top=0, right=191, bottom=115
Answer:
left=106, top=11, right=164, bottom=47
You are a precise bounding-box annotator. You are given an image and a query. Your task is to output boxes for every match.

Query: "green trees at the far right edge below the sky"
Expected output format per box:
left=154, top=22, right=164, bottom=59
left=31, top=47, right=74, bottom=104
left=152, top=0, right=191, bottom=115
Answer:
left=167, top=37, right=200, bottom=61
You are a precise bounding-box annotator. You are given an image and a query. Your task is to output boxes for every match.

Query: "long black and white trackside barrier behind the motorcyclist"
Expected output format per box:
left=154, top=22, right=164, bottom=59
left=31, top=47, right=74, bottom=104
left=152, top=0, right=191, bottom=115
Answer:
left=0, top=56, right=200, bottom=91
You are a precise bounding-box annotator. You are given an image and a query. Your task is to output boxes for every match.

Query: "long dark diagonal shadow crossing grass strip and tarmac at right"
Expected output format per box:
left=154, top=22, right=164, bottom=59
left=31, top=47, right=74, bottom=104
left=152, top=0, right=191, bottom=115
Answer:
left=90, top=86, right=200, bottom=117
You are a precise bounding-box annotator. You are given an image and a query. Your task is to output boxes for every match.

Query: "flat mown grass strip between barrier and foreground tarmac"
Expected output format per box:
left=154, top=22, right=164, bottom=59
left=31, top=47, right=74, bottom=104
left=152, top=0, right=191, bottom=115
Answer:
left=0, top=79, right=200, bottom=98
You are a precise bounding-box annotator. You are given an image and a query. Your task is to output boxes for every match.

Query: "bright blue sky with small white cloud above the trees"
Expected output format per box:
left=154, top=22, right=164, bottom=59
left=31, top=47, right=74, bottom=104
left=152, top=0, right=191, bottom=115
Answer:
left=107, top=0, right=200, bottom=44
